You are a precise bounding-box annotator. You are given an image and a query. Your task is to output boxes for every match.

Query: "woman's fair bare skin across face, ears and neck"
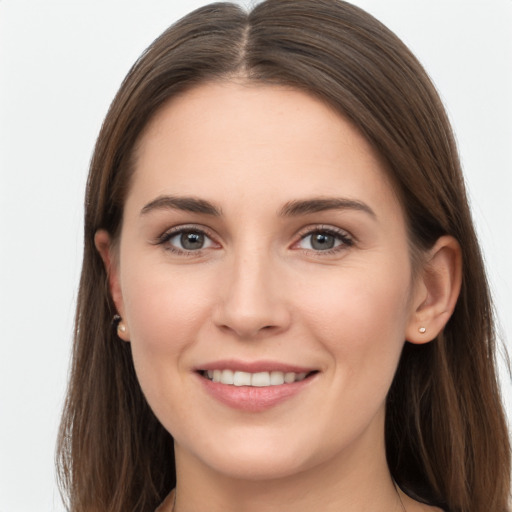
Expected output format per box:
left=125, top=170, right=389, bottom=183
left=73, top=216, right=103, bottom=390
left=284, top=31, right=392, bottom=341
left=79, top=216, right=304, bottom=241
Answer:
left=96, top=81, right=460, bottom=512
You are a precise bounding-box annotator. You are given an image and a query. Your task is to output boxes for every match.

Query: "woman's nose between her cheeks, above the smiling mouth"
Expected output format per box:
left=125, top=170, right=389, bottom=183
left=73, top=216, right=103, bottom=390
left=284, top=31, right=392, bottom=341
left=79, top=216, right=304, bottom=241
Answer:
left=213, top=250, right=291, bottom=340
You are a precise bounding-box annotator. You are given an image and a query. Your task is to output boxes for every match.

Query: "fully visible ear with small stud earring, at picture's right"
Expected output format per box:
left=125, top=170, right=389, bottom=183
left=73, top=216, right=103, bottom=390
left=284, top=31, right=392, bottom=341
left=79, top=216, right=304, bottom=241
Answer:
left=406, top=236, right=462, bottom=344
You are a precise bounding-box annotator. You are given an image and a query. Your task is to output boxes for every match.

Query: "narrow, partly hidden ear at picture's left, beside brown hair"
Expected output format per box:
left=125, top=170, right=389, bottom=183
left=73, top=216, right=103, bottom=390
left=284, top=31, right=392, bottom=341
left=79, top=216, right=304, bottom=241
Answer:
left=94, top=229, right=129, bottom=341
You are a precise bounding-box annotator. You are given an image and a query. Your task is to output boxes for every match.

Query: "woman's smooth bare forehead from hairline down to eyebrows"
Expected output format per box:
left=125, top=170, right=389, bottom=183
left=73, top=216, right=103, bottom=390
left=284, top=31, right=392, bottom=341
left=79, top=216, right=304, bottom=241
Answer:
left=129, top=81, right=399, bottom=220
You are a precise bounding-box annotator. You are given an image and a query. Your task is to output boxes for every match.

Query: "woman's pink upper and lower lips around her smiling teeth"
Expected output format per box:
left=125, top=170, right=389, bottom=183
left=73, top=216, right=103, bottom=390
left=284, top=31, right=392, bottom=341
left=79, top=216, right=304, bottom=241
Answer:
left=196, top=360, right=318, bottom=413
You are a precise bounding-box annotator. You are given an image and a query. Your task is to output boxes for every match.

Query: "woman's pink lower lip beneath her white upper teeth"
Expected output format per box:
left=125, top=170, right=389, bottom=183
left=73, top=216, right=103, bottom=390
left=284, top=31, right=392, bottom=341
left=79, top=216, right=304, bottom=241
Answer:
left=198, top=374, right=316, bottom=412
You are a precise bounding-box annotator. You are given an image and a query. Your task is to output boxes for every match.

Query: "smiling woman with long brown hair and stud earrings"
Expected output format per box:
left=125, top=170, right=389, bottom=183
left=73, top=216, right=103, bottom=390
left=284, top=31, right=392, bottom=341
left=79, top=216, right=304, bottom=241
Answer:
left=54, top=0, right=510, bottom=512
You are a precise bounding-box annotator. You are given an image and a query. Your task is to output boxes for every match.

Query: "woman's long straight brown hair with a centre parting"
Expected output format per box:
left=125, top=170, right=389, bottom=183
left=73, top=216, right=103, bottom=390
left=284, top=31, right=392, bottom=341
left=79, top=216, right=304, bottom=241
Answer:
left=58, top=0, right=510, bottom=512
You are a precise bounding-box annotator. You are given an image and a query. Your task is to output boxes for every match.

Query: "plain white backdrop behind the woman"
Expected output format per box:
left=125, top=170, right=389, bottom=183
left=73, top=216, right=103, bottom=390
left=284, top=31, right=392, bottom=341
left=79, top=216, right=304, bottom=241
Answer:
left=0, top=0, right=512, bottom=512
